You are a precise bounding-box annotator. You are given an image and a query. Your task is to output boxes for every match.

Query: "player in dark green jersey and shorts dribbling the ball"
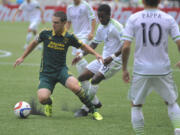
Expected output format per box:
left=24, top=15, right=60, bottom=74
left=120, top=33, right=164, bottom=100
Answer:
left=14, top=11, right=103, bottom=120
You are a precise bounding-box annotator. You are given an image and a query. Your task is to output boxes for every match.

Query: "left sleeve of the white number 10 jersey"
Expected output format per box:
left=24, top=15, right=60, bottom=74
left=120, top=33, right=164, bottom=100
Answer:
left=122, top=17, right=134, bottom=41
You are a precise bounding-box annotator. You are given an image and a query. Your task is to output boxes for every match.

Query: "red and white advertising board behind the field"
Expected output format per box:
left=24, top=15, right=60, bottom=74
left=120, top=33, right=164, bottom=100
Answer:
left=0, top=5, right=180, bottom=24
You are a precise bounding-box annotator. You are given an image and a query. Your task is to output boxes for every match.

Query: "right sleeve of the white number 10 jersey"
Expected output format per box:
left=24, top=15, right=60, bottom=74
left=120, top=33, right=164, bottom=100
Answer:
left=170, top=17, right=180, bottom=42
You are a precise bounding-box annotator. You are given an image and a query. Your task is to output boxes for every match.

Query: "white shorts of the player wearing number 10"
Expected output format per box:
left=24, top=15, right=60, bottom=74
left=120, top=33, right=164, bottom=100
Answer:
left=128, top=73, right=178, bottom=105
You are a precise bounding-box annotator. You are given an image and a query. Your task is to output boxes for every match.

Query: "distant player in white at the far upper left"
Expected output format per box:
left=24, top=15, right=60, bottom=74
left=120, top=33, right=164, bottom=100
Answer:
left=13, top=0, right=44, bottom=49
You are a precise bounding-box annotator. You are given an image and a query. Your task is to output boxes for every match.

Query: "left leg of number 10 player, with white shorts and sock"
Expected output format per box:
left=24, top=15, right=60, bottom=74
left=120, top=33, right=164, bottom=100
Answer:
left=128, top=74, right=152, bottom=135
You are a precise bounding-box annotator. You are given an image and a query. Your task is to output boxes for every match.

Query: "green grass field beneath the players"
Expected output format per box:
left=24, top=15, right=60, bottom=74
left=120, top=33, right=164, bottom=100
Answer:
left=0, top=22, right=180, bottom=135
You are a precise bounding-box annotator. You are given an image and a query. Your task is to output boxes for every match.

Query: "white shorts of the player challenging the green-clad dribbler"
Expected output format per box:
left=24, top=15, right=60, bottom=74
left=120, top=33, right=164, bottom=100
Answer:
left=86, top=60, right=122, bottom=79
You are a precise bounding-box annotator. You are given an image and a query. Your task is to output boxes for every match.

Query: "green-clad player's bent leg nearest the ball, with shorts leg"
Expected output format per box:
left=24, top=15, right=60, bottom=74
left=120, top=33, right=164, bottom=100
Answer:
left=37, top=74, right=56, bottom=117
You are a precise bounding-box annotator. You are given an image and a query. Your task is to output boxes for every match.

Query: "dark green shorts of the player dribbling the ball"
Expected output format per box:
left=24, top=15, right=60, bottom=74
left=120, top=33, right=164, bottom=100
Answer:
left=38, top=66, right=72, bottom=93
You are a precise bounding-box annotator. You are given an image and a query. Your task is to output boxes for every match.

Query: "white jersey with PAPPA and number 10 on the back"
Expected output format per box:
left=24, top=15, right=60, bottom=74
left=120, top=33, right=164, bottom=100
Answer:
left=123, top=9, right=180, bottom=75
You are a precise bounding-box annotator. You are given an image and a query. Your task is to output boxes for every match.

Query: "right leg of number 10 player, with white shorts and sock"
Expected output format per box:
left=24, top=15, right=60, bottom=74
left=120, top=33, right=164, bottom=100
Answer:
left=153, top=74, right=180, bottom=135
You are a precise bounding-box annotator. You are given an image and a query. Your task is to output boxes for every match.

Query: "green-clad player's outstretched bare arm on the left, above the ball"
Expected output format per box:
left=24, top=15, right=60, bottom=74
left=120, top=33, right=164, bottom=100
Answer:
left=14, top=40, right=39, bottom=67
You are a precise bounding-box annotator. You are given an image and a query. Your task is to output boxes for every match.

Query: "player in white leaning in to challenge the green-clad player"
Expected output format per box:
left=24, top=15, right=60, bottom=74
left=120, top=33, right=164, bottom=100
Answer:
left=73, top=4, right=123, bottom=117
